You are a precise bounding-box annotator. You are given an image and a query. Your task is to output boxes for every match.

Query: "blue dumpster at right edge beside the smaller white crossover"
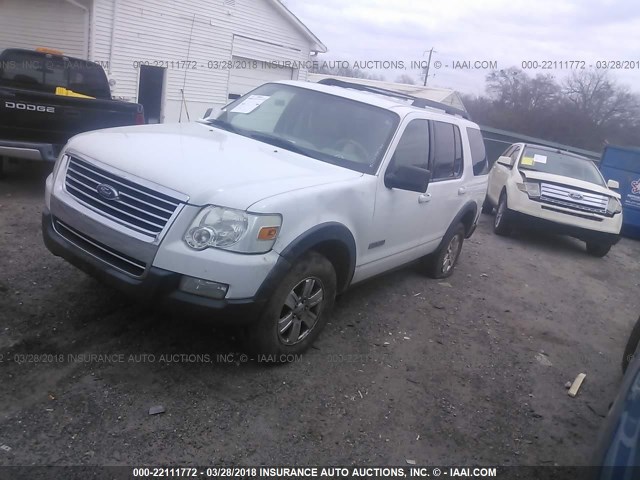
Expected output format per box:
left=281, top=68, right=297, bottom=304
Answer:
left=600, top=145, right=640, bottom=238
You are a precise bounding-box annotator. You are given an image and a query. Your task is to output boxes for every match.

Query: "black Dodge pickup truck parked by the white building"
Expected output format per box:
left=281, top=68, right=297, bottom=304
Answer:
left=0, top=49, right=144, bottom=173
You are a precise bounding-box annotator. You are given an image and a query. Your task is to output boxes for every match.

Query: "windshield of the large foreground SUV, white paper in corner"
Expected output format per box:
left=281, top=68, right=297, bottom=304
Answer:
left=209, top=83, right=399, bottom=173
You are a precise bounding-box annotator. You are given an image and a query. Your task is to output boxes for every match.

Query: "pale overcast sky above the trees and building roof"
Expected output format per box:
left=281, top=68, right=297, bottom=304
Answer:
left=284, top=0, right=640, bottom=94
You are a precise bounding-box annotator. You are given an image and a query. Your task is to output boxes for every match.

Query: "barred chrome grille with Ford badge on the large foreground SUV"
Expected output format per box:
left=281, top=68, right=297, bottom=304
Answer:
left=65, top=157, right=180, bottom=236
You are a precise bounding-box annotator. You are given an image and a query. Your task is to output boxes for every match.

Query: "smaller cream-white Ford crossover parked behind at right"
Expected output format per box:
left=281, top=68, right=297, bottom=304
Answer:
left=482, top=143, right=622, bottom=257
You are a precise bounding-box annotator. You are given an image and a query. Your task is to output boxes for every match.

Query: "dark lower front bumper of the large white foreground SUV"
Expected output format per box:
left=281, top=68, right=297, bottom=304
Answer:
left=42, top=210, right=268, bottom=325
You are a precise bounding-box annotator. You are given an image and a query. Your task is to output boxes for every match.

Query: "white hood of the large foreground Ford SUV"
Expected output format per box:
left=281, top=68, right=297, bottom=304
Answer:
left=67, top=123, right=362, bottom=210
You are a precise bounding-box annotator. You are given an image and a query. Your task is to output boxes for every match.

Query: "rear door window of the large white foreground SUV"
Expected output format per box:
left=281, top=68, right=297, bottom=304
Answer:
left=432, top=122, right=463, bottom=180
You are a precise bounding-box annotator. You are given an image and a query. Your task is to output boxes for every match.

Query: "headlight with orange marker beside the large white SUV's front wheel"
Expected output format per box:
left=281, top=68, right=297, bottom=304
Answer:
left=184, top=205, right=282, bottom=253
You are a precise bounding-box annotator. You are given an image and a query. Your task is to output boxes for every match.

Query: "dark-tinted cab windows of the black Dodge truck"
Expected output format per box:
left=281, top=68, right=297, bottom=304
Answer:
left=0, top=50, right=111, bottom=99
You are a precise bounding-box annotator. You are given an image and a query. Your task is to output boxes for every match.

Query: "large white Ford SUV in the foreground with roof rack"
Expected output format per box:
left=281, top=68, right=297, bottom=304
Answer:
left=43, top=81, right=488, bottom=355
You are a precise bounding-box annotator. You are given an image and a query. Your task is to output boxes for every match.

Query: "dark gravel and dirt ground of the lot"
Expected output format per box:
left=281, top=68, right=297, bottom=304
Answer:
left=0, top=169, right=640, bottom=465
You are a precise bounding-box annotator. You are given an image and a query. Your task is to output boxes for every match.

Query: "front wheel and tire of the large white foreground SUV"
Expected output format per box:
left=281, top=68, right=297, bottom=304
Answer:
left=247, top=252, right=336, bottom=356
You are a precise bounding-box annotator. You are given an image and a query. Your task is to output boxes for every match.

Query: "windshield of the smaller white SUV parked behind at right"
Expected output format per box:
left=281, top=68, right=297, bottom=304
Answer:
left=519, top=147, right=605, bottom=186
